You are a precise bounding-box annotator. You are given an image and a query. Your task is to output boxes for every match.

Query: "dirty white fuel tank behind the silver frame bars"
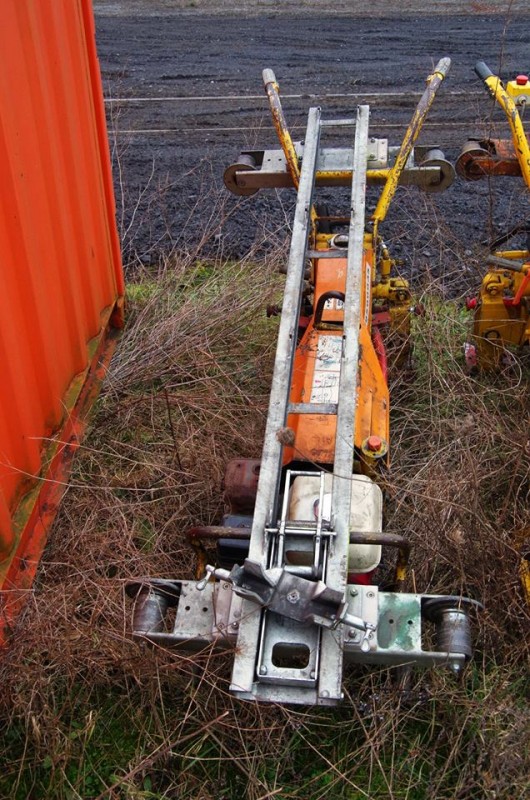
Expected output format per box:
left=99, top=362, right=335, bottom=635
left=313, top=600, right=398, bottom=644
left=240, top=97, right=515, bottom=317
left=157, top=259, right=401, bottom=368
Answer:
left=289, top=473, right=383, bottom=573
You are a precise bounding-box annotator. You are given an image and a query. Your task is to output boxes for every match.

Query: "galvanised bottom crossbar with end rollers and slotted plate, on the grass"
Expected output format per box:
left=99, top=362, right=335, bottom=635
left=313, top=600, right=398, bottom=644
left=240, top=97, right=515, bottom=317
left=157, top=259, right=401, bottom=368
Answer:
left=128, top=576, right=481, bottom=705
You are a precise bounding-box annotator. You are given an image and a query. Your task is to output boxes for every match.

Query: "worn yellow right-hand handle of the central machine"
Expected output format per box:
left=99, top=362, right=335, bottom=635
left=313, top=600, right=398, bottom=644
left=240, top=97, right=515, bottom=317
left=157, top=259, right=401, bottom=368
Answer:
left=372, top=58, right=451, bottom=237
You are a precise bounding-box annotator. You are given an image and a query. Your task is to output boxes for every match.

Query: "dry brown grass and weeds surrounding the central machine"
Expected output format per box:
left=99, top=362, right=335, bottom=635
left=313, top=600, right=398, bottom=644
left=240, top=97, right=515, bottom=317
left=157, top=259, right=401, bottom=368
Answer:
left=0, top=208, right=530, bottom=800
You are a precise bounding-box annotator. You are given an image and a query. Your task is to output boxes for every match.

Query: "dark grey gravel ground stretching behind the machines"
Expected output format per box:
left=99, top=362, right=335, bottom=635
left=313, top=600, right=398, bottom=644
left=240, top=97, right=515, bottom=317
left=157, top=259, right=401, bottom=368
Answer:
left=95, top=0, right=530, bottom=293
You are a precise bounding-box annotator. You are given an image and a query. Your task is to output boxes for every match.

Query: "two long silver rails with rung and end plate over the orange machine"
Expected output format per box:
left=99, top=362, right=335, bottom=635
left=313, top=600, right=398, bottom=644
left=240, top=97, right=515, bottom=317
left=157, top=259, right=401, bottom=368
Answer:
left=231, top=106, right=369, bottom=704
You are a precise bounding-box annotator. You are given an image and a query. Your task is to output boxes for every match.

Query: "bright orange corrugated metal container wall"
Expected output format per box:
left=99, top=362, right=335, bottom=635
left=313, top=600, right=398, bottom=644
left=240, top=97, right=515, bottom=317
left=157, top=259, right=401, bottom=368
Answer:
left=0, top=0, right=123, bottom=636
